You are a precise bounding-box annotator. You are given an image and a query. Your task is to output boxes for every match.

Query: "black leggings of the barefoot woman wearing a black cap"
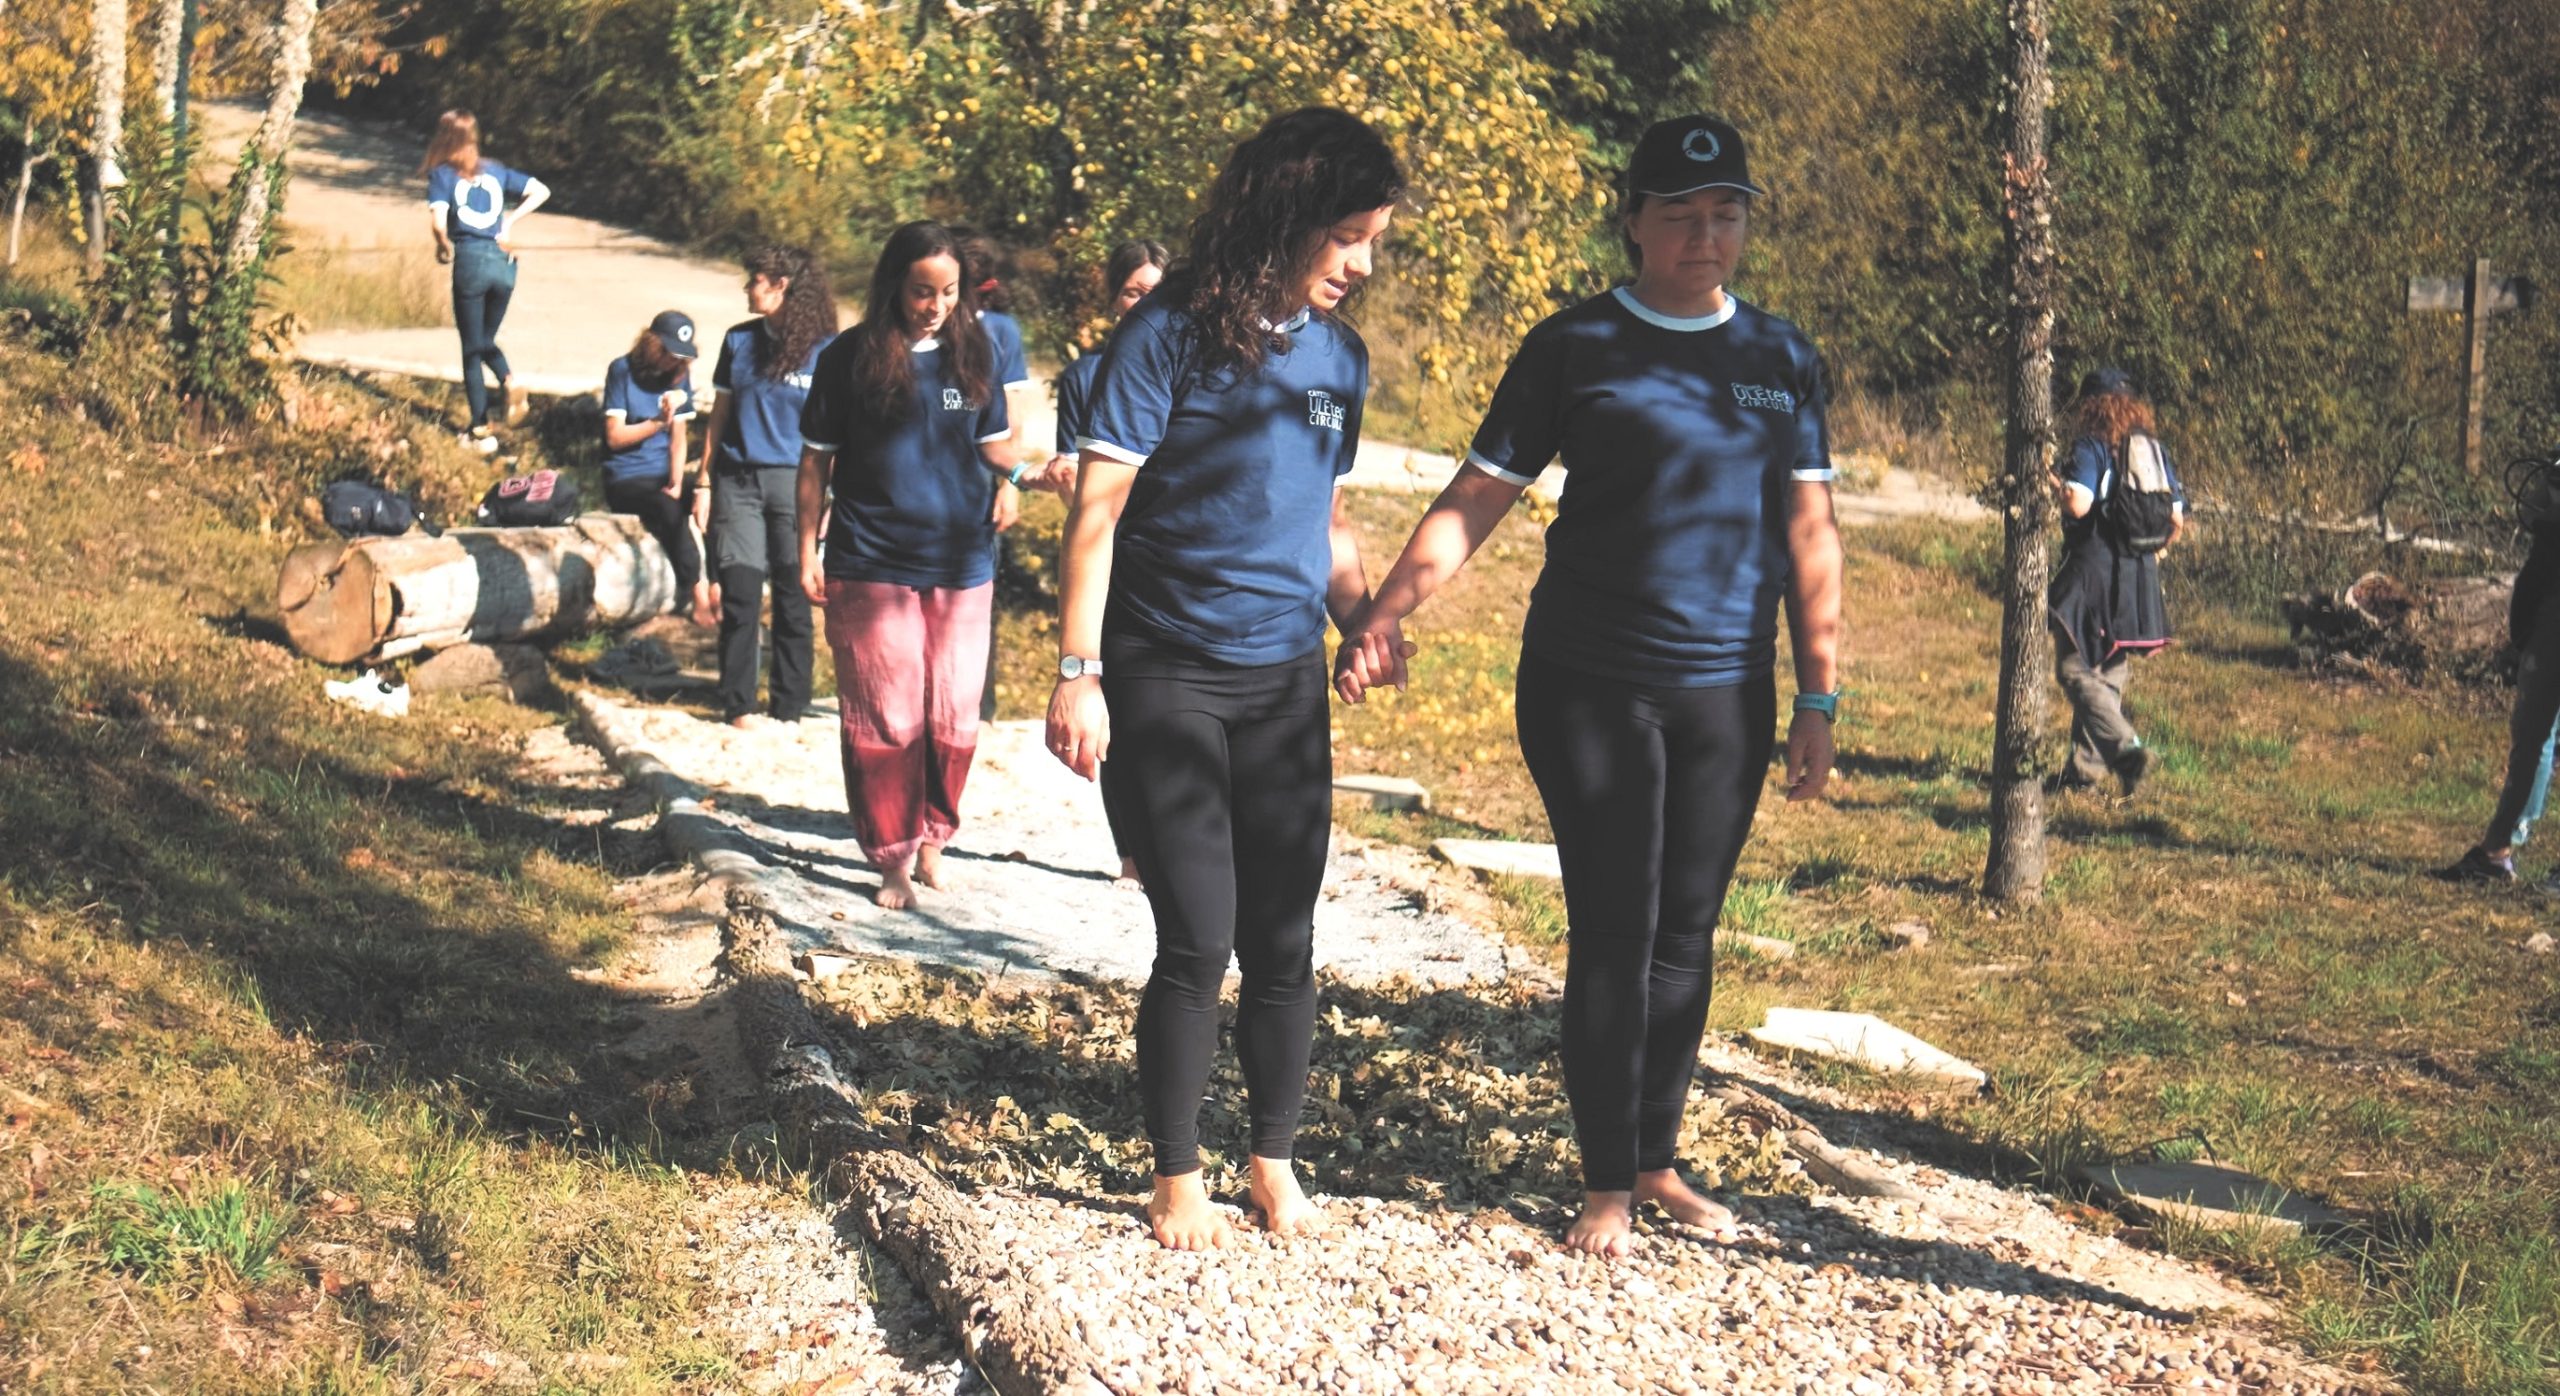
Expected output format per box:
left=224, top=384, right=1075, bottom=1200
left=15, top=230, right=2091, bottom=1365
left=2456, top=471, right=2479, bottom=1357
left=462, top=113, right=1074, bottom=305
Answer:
left=1518, top=656, right=1777, bottom=1191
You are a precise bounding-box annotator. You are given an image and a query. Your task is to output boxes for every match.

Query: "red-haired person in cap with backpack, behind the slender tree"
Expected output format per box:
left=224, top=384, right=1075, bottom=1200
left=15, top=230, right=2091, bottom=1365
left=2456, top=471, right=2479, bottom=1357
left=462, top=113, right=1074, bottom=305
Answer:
left=2045, top=369, right=2186, bottom=799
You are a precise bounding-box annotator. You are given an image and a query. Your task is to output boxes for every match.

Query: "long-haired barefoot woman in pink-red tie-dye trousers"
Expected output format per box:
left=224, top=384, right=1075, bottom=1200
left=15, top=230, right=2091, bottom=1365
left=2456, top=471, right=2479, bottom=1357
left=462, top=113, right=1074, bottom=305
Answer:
left=799, top=223, right=1060, bottom=909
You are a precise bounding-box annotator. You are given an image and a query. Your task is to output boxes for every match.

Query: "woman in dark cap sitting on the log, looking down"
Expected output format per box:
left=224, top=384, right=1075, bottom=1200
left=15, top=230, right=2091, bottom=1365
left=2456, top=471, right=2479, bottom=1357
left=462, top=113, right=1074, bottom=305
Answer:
left=604, top=310, right=712, bottom=625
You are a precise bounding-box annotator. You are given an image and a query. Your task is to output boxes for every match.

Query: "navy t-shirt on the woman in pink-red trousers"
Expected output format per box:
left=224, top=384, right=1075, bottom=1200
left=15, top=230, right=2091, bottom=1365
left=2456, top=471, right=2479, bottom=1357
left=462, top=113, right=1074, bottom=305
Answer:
left=801, top=336, right=1011, bottom=587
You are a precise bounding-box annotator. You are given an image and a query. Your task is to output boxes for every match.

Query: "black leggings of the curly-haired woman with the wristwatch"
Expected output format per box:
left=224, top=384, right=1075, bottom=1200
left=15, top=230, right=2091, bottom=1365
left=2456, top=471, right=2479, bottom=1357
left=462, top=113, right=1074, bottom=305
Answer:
left=1103, top=638, right=1334, bottom=1178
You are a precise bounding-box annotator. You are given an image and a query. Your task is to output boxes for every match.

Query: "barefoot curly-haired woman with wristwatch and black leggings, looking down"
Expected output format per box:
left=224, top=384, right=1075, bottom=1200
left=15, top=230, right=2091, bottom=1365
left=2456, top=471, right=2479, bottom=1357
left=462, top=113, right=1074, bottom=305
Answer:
left=1050, top=108, right=1405, bottom=1250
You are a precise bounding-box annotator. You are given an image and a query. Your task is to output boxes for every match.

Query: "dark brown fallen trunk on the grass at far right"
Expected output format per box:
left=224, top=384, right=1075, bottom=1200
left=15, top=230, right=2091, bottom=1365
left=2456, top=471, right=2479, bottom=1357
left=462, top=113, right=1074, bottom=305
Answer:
left=2284, top=571, right=2516, bottom=676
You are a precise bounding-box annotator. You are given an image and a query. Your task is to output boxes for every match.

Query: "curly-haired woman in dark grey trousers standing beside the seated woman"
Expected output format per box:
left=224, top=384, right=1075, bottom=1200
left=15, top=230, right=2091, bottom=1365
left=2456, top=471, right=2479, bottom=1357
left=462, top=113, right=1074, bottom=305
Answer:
left=694, top=246, right=837, bottom=727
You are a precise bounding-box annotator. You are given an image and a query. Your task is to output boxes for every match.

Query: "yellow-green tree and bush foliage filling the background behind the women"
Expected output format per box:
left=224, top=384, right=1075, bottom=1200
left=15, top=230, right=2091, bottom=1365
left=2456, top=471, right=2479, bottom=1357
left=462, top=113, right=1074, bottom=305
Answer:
left=361, top=0, right=2560, bottom=525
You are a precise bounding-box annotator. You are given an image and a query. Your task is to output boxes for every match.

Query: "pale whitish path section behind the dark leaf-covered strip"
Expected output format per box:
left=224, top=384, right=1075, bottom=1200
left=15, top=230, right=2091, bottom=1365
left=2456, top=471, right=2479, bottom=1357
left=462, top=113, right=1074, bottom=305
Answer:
left=591, top=699, right=1505, bottom=984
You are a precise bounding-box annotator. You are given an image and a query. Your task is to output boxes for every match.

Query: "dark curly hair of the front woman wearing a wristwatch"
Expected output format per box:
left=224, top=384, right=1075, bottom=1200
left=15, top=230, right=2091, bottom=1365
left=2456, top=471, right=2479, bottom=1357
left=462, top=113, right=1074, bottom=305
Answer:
left=1157, top=108, right=1405, bottom=371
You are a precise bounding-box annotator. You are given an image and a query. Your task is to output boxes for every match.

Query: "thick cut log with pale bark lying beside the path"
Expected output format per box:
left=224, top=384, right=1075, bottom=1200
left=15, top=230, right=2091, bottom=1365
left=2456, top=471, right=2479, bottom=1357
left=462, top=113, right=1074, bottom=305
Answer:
left=276, top=515, right=676, bottom=663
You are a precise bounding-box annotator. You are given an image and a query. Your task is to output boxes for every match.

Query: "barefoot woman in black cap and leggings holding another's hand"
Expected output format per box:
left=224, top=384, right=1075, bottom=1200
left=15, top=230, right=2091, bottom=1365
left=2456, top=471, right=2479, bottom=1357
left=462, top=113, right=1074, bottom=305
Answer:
left=1336, top=115, right=1841, bottom=1255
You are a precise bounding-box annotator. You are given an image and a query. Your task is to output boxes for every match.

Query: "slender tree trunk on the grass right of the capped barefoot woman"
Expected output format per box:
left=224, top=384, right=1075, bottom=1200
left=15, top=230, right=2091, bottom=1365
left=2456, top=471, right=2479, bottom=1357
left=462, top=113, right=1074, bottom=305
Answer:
left=1981, top=0, right=2056, bottom=902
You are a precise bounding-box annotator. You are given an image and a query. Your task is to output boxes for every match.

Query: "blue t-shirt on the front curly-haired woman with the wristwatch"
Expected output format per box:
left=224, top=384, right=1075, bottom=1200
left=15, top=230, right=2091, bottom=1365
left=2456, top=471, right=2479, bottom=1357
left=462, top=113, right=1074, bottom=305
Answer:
left=1075, top=297, right=1370, bottom=663
